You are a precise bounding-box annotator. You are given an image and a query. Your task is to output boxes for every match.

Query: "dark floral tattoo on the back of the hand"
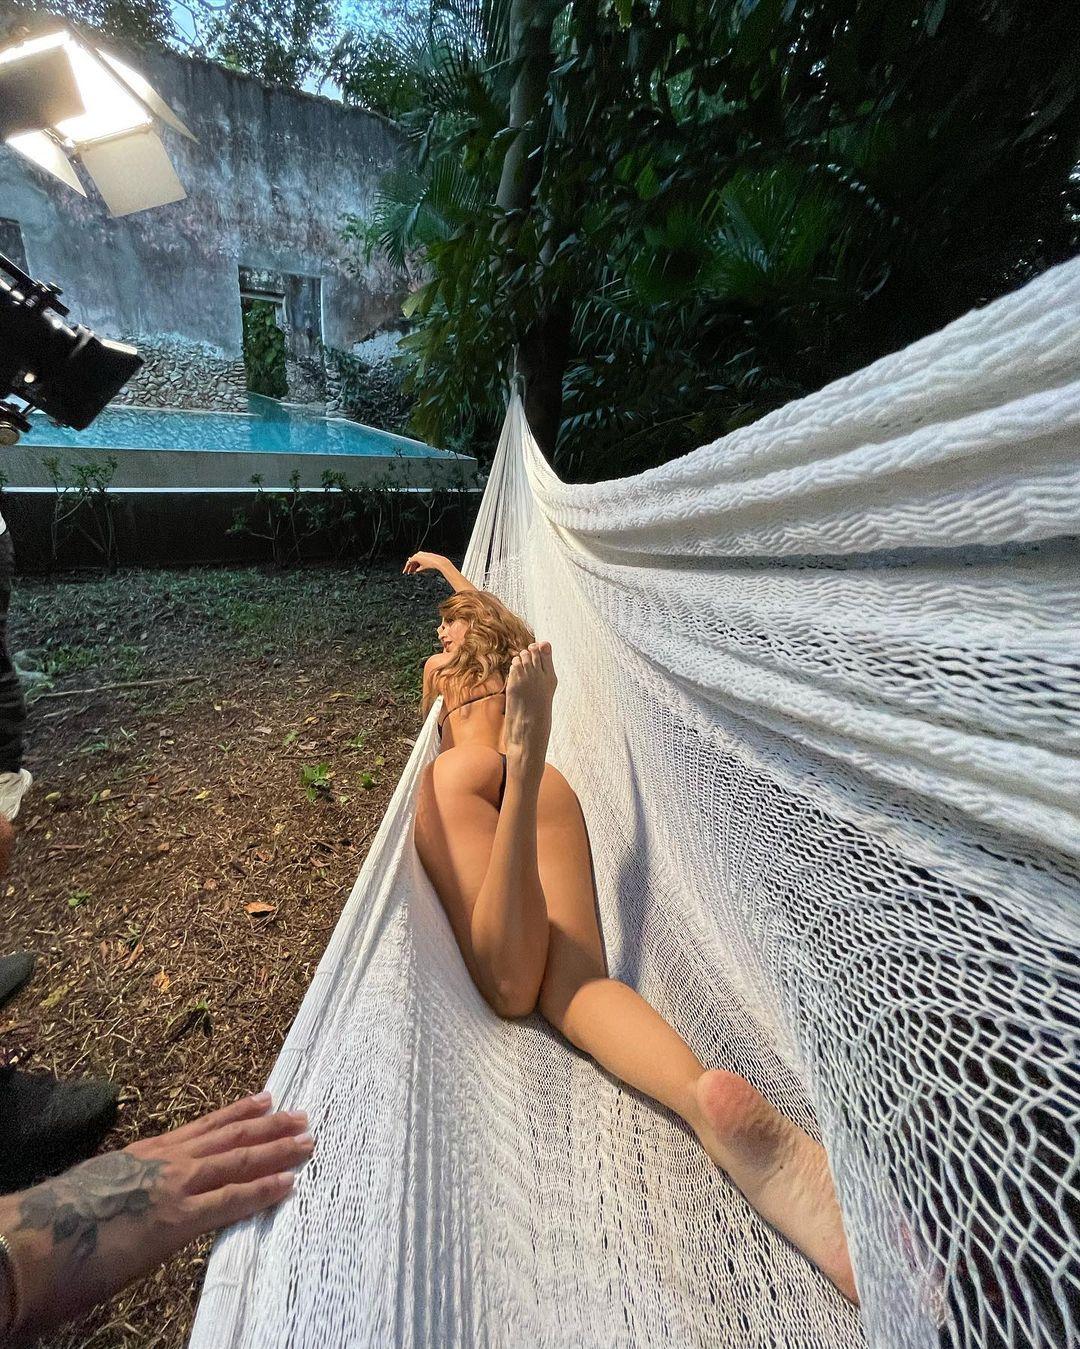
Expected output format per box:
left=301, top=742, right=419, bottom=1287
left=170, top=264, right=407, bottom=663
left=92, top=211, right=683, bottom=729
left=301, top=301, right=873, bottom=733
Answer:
left=15, top=1152, right=166, bottom=1260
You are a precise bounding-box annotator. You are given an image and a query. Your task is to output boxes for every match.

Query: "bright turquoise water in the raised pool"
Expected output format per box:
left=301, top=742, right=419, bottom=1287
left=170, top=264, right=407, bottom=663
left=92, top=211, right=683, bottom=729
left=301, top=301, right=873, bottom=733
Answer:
left=23, top=394, right=452, bottom=457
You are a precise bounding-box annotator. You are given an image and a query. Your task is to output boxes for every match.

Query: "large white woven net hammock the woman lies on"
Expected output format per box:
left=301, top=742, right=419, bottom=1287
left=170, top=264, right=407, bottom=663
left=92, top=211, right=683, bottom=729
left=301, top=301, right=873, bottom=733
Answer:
left=191, top=259, right=1080, bottom=1349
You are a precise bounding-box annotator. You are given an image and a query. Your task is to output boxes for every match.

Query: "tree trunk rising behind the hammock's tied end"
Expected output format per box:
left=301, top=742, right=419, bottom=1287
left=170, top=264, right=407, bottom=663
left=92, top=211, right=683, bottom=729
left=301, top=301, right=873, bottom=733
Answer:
left=495, top=0, right=569, bottom=459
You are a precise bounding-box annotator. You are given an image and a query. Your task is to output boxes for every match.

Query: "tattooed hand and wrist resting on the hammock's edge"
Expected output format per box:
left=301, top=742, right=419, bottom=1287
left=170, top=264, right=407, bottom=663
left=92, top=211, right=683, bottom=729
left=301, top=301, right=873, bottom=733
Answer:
left=0, top=1093, right=313, bottom=1344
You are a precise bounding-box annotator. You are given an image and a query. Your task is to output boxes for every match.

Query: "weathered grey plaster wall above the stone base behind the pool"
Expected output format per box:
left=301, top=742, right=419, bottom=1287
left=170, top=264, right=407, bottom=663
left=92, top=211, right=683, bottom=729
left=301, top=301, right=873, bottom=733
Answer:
left=0, top=43, right=404, bottom=360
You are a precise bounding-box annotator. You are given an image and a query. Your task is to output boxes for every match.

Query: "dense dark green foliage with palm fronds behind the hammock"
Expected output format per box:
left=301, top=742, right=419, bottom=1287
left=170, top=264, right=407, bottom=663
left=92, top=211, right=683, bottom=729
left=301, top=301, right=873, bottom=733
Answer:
left=353, top=0, right=1080, bottom=478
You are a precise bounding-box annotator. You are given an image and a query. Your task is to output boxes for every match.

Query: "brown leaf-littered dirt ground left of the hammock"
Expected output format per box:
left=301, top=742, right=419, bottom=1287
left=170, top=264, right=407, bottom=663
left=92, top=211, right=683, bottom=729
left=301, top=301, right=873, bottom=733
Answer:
left=0, top=567, right=444, bottom=1349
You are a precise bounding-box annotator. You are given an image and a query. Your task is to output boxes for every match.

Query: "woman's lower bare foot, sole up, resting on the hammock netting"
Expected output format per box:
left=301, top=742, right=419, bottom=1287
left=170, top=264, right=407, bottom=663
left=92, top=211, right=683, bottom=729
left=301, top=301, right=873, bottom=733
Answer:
left=694, top=1071, right=859, bottom=1304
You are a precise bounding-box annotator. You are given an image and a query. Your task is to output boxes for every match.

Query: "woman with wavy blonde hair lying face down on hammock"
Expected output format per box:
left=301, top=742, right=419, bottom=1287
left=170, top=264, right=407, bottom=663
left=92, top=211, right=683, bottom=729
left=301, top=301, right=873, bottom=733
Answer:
left=404, top=553, right=858, bottom=1300
